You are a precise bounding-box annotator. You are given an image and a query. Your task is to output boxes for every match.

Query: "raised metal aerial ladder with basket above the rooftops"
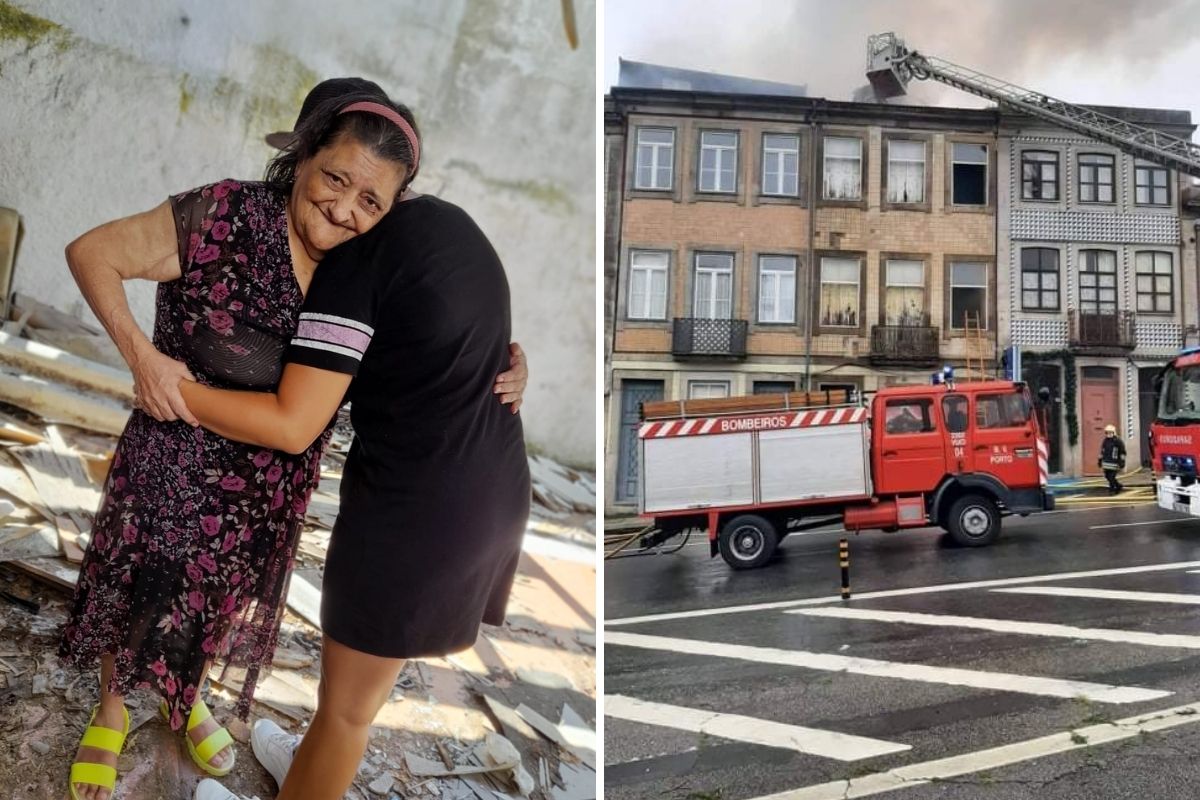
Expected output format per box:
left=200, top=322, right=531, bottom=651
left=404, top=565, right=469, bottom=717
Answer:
left=866, top=32, right=1200, bottom=178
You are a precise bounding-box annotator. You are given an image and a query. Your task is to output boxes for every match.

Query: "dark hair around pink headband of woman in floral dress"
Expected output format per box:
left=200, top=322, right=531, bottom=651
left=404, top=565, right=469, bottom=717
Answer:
left=265, top=92, right=421, bottom=192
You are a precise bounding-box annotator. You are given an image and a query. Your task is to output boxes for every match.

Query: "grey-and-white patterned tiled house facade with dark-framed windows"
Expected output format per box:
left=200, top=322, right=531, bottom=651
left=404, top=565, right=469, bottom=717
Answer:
left=997, top=109, right=1196, bottom=475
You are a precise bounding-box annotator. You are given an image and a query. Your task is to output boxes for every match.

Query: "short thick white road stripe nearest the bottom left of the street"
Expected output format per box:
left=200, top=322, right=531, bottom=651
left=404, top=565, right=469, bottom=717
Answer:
left=604, top=694, right=912, bottom=762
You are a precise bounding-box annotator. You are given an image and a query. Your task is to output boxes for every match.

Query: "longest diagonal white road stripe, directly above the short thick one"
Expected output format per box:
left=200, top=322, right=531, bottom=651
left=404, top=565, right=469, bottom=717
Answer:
left=605, top=631, right=1171, bottom=703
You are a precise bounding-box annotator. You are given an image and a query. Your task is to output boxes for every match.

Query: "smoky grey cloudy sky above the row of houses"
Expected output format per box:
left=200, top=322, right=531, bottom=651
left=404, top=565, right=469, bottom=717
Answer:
left=601, top=0, right=1200, bottom=138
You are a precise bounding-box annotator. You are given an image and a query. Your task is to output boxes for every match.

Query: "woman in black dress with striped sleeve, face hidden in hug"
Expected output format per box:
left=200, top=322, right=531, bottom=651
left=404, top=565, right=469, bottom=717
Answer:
left=180, top=183, right=529, bottom=800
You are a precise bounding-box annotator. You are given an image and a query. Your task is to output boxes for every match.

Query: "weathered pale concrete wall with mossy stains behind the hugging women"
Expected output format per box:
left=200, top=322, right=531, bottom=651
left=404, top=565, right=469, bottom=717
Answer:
left=0, top=0, right=596, bottom=464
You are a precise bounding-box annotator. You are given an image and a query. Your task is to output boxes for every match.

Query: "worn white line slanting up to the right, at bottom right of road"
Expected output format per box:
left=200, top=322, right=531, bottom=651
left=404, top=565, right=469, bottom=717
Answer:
left=754, top=703, right=1200, bottom=800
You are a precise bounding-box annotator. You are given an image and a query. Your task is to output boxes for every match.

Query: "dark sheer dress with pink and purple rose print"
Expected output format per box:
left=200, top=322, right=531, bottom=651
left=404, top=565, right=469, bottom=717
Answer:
left=60, top=180, right=329, bottom=729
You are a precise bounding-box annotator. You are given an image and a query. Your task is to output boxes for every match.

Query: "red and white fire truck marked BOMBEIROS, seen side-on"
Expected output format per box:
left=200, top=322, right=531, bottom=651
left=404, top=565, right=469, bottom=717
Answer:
left=638, top=380, right=1054, bottom=570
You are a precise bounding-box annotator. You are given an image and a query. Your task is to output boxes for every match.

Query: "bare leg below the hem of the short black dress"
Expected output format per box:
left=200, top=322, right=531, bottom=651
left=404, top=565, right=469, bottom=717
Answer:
left=278, top=636, right=404, bottom=800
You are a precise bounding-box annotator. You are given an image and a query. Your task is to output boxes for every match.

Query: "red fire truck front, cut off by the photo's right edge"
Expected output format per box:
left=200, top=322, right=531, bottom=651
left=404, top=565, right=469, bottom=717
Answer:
left=1150, top=348, right=1200, bottom=517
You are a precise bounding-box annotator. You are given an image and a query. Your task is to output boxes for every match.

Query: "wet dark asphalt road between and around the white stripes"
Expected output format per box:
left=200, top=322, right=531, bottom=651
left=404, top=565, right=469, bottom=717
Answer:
left=604, top=506, right=1200, bottom=800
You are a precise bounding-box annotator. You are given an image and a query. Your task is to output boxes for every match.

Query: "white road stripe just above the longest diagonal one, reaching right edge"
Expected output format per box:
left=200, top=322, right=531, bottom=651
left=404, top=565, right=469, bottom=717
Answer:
left=786, top=606, right=1200, bottom=650
